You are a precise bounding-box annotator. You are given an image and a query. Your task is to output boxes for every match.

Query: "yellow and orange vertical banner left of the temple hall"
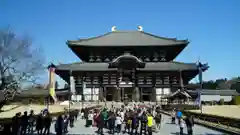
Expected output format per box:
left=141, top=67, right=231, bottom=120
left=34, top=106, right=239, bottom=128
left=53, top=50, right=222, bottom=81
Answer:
left=49, top=67, right=57, bottom=102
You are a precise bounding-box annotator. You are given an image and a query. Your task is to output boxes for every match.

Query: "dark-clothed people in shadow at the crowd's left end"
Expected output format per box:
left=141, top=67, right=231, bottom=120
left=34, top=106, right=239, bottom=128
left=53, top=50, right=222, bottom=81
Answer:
left=1, top=109, right=79, bottom=135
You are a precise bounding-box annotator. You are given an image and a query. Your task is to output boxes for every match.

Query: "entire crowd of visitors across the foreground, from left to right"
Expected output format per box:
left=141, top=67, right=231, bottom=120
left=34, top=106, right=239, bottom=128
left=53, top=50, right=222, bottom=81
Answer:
left=2, top=105, right=194, bottom=135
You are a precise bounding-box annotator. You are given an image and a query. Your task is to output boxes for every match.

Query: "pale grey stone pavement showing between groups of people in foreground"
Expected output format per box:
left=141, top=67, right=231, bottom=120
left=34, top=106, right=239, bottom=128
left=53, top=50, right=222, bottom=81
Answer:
left=47, top=115, right=224, bottom=135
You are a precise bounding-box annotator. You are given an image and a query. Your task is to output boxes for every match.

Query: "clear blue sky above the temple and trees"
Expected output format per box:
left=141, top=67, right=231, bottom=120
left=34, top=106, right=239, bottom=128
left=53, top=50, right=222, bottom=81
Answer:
left=0, top=0, right=240, bottom=86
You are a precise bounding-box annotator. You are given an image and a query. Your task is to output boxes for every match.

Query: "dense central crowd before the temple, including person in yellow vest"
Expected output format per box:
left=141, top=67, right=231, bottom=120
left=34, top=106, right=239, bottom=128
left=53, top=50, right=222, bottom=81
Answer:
left=82, top=106, right=163, bottom=135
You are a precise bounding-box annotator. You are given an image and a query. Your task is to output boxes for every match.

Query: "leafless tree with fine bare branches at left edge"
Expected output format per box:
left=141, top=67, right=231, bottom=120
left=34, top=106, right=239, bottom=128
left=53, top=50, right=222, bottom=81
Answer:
left=0, top=26, right=44, bottom=105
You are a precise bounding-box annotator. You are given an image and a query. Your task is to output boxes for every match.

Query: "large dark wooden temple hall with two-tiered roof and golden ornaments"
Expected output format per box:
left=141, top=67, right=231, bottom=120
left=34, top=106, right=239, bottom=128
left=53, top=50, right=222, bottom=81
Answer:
left=52, top=26, right=207, bottom=101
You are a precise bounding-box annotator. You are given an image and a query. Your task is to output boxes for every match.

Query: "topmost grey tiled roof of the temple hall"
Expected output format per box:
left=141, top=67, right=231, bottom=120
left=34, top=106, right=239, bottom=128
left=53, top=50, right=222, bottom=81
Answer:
left=67, top=31, right=189, bottom=46
